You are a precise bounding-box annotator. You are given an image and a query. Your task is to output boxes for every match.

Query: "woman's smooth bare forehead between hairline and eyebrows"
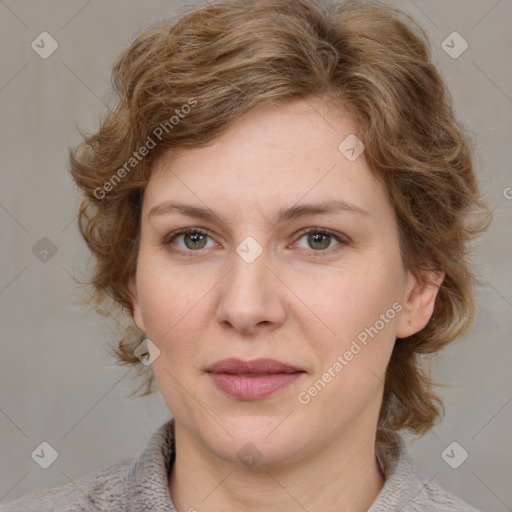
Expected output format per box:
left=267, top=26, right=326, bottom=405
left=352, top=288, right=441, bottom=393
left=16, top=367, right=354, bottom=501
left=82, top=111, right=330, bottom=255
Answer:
left=144, top=100, right=392, bottom=223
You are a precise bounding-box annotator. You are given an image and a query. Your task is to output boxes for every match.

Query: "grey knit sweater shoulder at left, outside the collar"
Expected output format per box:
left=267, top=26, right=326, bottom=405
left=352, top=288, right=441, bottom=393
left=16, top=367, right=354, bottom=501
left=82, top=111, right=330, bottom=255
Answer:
left=0, top=461, right=131, bottom=512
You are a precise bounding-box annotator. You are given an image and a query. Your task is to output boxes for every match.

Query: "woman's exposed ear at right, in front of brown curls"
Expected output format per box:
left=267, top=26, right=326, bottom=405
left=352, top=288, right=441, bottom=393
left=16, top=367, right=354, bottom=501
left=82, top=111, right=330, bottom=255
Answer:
left=396, top=270, right=445, bottom=338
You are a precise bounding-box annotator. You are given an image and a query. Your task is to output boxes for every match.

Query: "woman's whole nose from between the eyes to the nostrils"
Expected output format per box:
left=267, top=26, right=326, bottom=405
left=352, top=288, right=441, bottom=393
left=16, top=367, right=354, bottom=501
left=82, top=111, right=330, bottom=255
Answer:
left=217, top=242, right=285, bottom=332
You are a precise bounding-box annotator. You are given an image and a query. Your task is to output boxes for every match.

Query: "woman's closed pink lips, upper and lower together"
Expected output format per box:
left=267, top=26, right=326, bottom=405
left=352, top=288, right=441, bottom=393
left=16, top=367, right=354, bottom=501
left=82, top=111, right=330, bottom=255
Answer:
left=206, top=358, right=306, bottom=400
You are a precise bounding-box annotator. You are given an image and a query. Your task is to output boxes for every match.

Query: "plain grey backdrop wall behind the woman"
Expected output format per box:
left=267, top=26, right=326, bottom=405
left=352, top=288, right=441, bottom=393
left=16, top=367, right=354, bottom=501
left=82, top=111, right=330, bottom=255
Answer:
left=0, top=0, right=512, bottom=512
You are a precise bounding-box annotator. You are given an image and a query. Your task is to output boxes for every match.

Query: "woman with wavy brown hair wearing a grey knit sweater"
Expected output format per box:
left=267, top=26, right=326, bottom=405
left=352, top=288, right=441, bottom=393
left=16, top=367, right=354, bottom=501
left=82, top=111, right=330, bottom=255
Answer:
left=5, top=0, right=490, bottom=512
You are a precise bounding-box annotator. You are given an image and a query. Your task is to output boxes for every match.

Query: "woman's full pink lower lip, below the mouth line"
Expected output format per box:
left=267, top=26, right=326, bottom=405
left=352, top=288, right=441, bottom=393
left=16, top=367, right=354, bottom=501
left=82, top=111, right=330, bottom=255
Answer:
left=208, top=372, right=304, bottom=400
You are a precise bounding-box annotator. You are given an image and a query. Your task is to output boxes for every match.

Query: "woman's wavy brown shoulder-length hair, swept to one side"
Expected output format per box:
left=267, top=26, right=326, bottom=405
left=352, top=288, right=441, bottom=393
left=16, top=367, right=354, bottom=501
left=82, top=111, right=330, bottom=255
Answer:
left=70, top=0, right=492, bottom=435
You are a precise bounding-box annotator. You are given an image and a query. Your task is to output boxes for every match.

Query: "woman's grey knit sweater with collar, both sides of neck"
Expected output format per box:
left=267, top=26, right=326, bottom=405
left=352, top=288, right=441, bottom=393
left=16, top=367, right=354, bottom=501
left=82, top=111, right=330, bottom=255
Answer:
left=0, top=419, right=478, bottom=512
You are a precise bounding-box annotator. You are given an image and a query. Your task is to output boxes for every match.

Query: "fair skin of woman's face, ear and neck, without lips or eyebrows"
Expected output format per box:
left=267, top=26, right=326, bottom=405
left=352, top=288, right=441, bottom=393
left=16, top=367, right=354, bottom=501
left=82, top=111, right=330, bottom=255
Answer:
left=130, top=99, right=444, bottom=512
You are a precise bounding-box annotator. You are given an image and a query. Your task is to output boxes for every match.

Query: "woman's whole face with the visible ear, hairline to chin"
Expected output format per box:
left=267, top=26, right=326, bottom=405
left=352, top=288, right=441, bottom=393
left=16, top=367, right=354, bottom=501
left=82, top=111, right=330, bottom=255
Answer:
left=131, top=101, right=437, bottom=466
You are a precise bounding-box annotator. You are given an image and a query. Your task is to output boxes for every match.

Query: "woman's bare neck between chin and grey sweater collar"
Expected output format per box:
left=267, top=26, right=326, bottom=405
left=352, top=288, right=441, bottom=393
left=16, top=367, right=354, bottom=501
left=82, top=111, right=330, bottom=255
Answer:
left=169, top=423, right=384, bottom=512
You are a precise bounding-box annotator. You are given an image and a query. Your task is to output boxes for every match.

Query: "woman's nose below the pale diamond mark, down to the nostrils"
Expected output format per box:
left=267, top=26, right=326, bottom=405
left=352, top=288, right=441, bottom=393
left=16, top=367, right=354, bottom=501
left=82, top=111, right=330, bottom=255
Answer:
left=216, top=251, right=286, bottom=334
